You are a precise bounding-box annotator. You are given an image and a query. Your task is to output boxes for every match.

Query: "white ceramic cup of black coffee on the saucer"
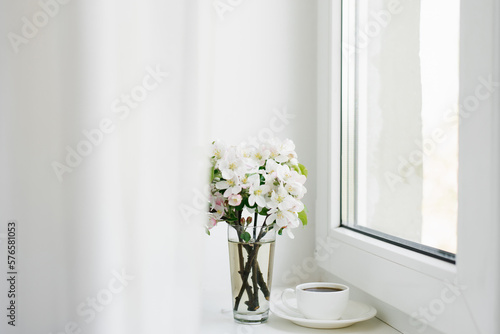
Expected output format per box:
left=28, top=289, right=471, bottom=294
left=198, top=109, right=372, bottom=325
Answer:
left=281, top=282, right=349, bottom=320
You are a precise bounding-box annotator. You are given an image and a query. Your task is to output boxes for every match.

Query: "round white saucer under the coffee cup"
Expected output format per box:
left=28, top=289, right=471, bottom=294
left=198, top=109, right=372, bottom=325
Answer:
left=270, top=300, right=377, bottom=329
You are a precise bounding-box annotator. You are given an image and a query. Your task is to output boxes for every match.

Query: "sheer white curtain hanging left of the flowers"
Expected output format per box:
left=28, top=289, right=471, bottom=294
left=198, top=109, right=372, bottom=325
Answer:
left=0, top=0, right=209, bottom=334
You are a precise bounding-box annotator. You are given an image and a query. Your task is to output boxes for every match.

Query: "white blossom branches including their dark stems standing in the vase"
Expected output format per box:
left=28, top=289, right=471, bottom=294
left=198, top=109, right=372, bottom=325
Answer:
left=207, top=139, right=307, bottom=311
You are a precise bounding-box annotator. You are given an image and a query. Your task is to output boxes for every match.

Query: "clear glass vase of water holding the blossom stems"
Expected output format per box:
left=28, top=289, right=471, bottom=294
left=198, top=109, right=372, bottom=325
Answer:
left=228, top=224, right=276, bottom=324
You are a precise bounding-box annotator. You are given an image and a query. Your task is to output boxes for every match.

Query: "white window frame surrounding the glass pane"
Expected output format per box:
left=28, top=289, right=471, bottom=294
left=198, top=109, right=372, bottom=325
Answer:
left=316, top=0, right=500, bottom=334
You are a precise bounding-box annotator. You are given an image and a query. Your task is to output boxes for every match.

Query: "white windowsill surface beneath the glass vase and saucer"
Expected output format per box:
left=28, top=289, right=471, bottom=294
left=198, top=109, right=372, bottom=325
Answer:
left=201, top=287, right=401, bottom=334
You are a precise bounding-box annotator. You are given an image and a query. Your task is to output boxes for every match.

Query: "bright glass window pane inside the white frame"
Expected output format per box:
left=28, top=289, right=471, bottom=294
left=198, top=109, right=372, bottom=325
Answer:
left=342, top=0, right=460, bottom=257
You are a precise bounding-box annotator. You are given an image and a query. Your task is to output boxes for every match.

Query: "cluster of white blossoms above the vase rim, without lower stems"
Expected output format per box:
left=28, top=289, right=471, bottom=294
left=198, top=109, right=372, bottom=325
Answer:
left=208, top=139, right=307, bottom=238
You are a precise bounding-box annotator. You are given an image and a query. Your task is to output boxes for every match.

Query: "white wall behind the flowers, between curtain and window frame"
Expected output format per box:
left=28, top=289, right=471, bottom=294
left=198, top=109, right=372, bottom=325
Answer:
left=203, top=0, right=316, bottom=308
